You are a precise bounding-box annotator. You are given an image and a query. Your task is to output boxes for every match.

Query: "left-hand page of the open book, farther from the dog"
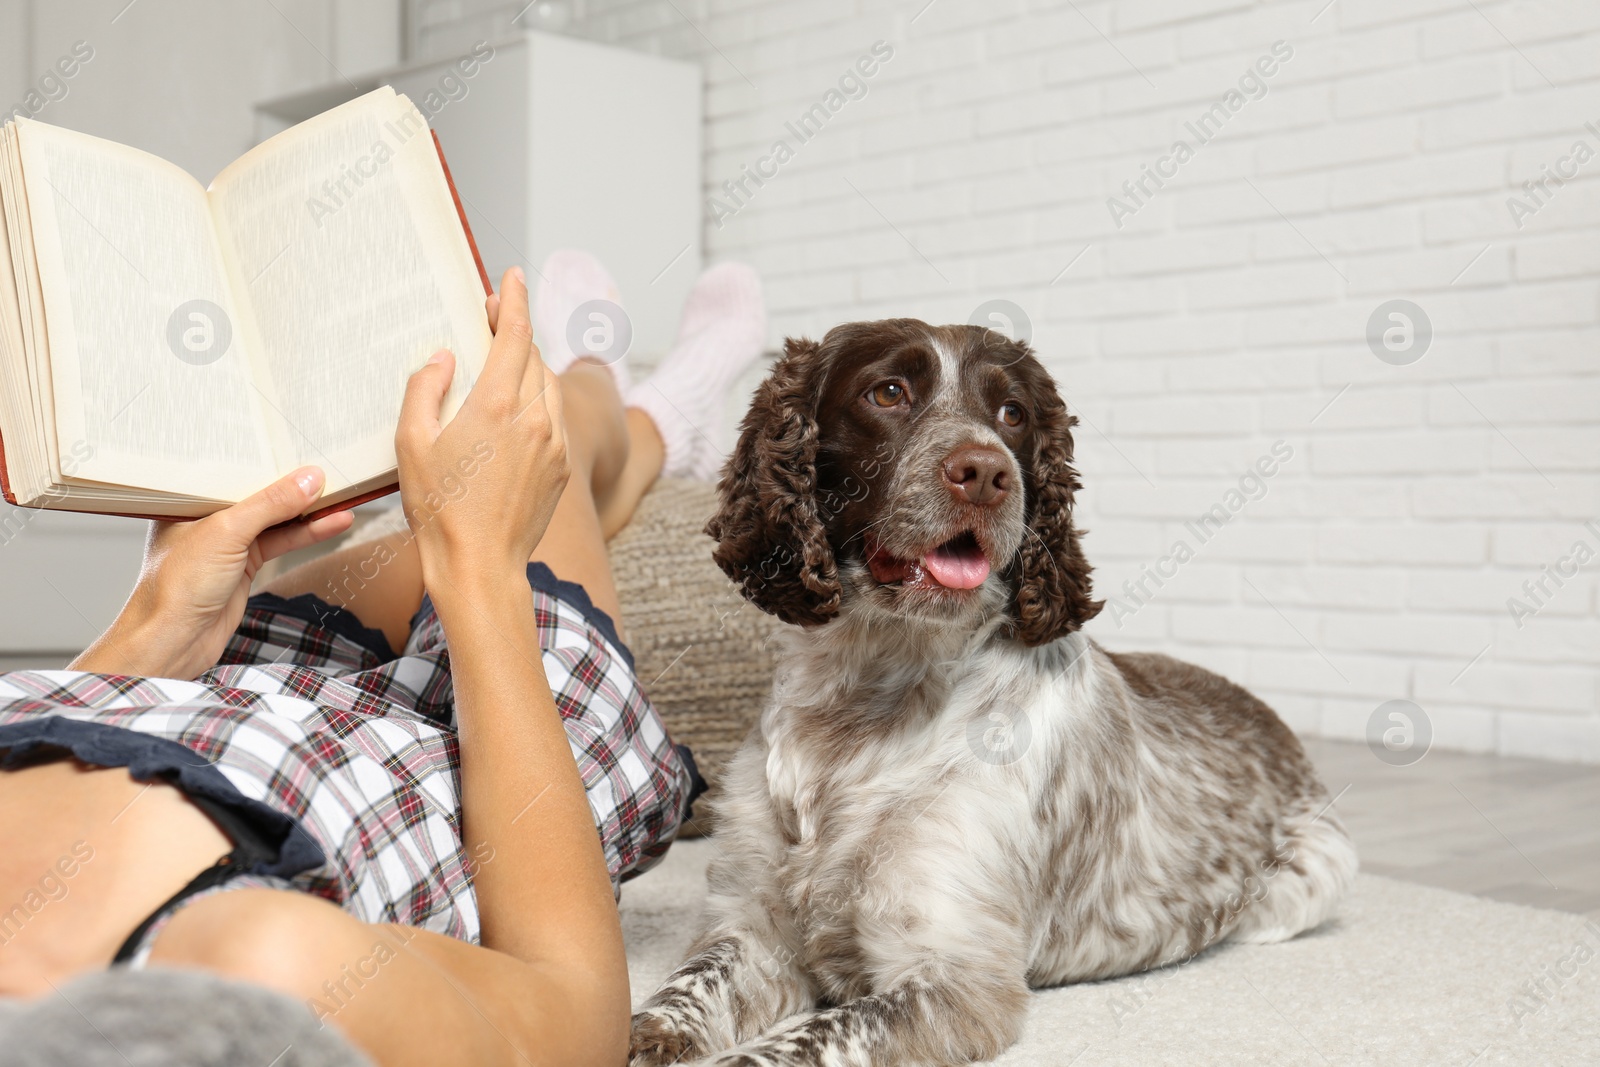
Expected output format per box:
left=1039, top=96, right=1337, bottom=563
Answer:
left=18, top=120, right=274, bottom=501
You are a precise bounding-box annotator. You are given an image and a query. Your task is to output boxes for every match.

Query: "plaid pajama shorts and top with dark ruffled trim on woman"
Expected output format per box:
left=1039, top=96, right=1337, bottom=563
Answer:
left=0, top=563, right=698, bottom=960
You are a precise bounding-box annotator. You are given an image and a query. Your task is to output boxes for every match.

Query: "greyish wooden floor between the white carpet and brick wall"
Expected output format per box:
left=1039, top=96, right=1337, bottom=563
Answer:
left=1304, top=739, right=1600, bottom=918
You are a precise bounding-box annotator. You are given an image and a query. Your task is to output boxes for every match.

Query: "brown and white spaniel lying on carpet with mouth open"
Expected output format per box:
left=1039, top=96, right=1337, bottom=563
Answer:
left=632, top=318, right=1357, bottom=1067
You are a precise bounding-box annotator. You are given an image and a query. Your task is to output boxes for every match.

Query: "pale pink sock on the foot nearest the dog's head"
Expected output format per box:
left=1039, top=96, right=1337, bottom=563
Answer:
left=626, top=262, right=766, bottom=482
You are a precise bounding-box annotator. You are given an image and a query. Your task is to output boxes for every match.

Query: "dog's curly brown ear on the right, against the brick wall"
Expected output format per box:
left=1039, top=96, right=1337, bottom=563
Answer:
left=1011, top=366, right=1106, bottom=645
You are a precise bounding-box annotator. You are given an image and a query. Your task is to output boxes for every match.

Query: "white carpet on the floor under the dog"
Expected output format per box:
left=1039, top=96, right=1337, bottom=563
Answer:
left=622, top=840, right=1600, bottom=1067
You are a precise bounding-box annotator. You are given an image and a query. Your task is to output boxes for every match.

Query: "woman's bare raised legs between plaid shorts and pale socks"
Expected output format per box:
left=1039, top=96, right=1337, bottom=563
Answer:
left=264, top=362, right=662, bottom=649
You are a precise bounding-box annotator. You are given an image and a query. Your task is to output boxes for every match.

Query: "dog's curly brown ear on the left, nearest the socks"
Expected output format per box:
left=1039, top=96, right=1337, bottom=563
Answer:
left=706, top=338, right=840, bottom=625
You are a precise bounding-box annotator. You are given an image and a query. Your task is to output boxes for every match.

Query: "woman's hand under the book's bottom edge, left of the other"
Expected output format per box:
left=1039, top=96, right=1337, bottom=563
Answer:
left=70, top=467, right=352, bottom=678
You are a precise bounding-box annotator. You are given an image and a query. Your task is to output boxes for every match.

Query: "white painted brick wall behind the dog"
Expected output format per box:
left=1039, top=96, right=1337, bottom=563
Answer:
left=419, top=0, right=1600, bottom=761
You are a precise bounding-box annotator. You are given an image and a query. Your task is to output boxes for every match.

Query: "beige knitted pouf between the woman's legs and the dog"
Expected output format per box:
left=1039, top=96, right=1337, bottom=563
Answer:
left=610, top=478, right=782, bottom=837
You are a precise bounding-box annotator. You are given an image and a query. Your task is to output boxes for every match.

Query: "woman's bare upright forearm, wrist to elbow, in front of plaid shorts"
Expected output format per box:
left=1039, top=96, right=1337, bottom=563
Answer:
left=430, top=574, right=627, bottom=1019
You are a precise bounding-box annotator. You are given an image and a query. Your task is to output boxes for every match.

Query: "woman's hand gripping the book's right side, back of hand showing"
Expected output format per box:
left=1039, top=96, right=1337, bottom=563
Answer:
left=395, top=267, right=568, bottom=603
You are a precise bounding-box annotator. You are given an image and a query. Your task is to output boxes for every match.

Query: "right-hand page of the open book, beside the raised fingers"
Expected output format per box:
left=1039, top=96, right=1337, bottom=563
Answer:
left=210, top=90, right=491, bottom=496
